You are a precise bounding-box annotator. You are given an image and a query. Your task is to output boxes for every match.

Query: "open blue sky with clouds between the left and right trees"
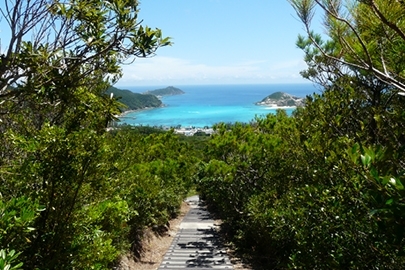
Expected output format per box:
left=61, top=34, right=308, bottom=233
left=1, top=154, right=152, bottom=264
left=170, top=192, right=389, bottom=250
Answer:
left=117, top=0, right=318, bottom=86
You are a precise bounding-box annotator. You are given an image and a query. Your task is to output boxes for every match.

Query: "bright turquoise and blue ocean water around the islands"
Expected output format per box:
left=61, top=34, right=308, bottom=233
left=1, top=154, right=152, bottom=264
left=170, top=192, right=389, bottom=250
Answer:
left=120, top=84, right=319, bottom=127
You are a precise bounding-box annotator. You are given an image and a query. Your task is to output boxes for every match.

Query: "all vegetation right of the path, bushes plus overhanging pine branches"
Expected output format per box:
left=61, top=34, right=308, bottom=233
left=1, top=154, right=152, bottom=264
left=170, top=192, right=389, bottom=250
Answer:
left=199, top=0, right=405, bottom=269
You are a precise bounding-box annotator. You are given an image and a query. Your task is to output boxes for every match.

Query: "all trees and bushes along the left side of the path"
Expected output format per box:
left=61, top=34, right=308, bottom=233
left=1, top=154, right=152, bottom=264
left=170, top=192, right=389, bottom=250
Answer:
left=0, top=0, right=186, bottom=269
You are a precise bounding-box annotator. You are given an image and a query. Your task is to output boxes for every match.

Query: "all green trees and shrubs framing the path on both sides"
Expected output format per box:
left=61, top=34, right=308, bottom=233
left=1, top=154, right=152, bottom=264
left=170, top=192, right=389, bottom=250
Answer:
left=0, top=0, right=405, bottom=269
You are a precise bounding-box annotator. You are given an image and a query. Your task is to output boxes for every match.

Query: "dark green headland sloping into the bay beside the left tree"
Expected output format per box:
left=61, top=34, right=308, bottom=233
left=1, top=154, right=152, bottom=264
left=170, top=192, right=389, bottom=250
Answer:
left=106, top=86, right=163, bottom=111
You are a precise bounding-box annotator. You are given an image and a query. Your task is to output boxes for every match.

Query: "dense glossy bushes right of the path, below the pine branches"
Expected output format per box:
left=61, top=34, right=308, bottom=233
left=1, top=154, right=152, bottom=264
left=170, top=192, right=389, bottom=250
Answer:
left=199, top=82, right=405, bottom=269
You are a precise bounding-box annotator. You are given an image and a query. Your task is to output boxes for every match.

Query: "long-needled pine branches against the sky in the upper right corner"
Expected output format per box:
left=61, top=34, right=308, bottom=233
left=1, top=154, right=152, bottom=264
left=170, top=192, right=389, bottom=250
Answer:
left=288, top=0, right=405, bottom=93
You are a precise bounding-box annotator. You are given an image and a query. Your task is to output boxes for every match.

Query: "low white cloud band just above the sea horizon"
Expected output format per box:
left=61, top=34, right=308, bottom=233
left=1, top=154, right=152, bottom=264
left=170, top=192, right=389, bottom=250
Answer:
left=118, top=56, right=305, bottom=85
